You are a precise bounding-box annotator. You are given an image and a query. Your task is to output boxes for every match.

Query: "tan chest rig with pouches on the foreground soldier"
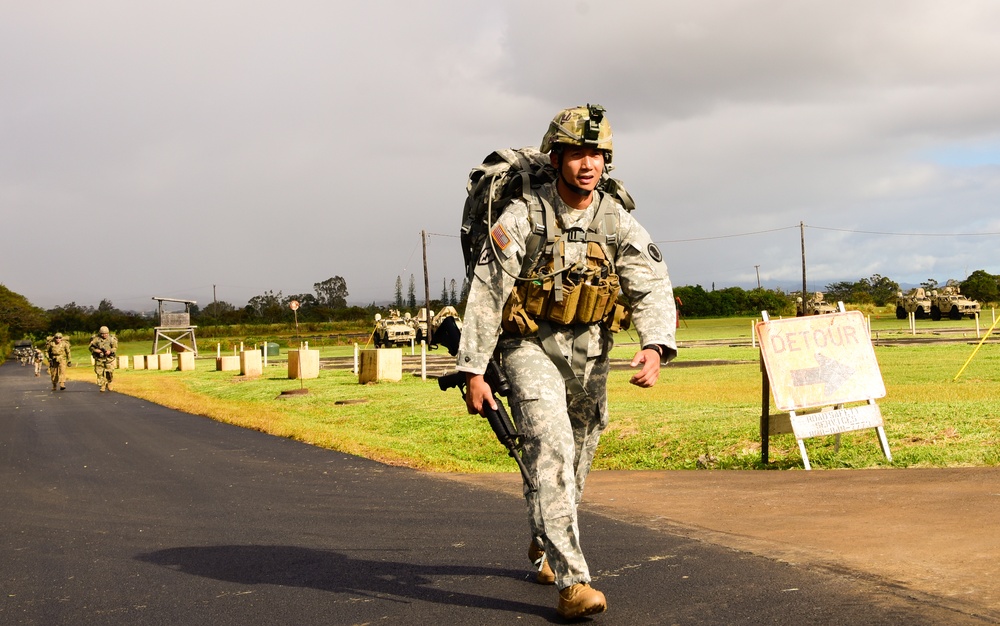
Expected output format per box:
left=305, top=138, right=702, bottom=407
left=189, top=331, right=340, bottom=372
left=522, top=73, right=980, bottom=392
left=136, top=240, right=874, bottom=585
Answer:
left=501, top=192, right=630, bottom=395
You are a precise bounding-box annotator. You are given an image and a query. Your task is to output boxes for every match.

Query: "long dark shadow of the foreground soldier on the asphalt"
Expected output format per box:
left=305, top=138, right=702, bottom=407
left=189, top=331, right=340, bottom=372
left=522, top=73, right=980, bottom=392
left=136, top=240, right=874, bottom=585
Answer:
left=135, top=545, right=553, bottom=618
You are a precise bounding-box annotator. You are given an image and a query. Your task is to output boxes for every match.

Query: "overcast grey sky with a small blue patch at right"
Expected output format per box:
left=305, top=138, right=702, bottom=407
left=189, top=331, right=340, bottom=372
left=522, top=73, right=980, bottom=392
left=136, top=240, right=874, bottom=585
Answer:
left=0, top=0, right=1000, bottom=310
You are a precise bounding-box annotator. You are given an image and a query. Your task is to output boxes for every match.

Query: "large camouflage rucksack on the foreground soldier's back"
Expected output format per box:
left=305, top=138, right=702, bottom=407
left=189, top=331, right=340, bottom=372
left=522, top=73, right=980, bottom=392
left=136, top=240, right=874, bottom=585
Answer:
left=460, top=147, right=635, bottom=284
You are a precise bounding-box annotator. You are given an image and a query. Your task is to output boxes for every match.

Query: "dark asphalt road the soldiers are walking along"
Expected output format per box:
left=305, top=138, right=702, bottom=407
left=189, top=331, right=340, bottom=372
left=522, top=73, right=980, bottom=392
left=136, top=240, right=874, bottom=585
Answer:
left=0, top=363, right=997, bottom=625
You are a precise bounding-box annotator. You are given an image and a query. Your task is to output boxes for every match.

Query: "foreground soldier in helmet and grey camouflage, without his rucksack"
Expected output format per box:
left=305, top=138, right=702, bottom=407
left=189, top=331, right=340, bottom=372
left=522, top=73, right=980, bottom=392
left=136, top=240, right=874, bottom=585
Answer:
left=457, top=105, right=677, bottom=618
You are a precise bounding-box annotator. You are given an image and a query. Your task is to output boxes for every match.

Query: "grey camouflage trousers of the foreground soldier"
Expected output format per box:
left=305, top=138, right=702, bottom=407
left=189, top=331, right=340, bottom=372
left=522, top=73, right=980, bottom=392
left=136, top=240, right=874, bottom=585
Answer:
left=503, top=341, right=608, bottom=589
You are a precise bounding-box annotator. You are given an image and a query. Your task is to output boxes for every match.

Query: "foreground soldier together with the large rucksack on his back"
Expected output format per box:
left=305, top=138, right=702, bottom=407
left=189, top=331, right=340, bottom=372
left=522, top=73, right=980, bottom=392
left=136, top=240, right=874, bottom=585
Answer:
left=457, top=105, right=677, bottom=618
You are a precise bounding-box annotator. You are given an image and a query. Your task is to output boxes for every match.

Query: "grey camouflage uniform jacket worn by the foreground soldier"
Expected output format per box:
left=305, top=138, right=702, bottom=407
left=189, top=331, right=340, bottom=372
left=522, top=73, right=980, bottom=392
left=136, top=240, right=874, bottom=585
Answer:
left=457, top=183, right=677, bottom=374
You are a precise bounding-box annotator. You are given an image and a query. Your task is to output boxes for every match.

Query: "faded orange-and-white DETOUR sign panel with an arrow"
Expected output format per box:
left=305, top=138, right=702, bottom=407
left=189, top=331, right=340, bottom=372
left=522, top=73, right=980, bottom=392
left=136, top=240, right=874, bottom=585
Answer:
left=756, top=311, right=885, bottom=411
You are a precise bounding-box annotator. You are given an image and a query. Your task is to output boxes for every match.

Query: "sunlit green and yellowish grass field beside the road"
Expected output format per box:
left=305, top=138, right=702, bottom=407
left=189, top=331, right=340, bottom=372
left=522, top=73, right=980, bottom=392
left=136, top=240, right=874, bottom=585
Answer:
left=64, top=313, right=1000, bottom=472
